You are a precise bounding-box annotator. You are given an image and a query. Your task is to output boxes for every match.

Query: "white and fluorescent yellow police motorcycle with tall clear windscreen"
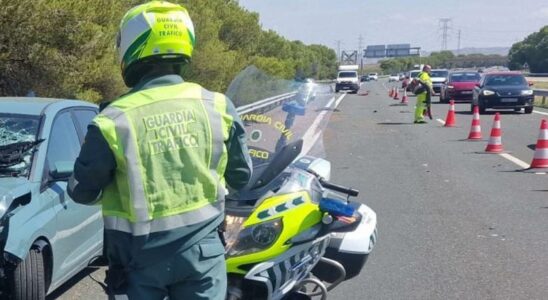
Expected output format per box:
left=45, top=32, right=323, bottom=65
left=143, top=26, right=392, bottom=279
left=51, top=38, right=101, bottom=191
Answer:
left=225, top=67, right=377, bottom=300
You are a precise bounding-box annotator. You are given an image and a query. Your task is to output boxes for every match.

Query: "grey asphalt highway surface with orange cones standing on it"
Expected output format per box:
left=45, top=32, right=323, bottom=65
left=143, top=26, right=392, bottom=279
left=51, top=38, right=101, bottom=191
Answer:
left=48, top=81, right=548, bottom=299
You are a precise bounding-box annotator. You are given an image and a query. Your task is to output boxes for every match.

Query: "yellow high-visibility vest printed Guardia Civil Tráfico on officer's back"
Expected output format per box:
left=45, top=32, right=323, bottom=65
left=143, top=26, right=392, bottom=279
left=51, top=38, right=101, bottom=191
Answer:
left=93, top=83, right=232, bottom=235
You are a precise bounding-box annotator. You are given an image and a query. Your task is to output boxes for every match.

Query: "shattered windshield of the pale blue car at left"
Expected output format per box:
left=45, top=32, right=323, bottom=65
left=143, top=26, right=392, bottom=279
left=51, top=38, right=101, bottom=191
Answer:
left=0, top=114, right=40, bottom=176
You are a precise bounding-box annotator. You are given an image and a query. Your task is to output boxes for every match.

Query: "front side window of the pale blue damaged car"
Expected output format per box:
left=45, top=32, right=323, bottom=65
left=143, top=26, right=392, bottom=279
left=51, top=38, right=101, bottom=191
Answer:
left=46, top=111, right=80, bottom=170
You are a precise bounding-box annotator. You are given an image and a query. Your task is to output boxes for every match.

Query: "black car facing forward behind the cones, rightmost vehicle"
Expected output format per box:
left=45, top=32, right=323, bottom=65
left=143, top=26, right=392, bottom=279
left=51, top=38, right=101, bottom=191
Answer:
left=470, top=72, right=534, bottom=114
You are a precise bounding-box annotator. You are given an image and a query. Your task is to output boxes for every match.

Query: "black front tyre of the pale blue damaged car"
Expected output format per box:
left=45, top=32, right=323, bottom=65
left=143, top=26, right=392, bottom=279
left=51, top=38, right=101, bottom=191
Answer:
left=12, top=249, right=46, bottom=300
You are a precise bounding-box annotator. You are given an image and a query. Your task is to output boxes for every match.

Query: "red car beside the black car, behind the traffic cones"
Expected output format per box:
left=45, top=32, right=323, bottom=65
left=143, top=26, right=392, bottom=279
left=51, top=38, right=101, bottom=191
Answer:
left=440, top=71, right=481, bottom=103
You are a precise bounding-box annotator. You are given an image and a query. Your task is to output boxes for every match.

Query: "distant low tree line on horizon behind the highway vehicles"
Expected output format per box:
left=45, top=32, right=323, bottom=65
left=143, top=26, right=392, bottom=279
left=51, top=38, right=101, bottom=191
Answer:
left=380, top=51, right=508, bottom=73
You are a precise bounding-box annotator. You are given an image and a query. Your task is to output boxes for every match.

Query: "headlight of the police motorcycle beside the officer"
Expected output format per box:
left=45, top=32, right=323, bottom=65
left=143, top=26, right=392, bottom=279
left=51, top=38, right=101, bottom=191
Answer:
left=228, top=218, right=283, bottom=256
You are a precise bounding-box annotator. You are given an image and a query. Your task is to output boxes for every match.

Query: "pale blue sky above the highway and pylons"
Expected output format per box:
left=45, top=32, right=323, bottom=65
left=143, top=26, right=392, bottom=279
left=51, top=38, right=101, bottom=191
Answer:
left=239, top=0, right=548, bottom=51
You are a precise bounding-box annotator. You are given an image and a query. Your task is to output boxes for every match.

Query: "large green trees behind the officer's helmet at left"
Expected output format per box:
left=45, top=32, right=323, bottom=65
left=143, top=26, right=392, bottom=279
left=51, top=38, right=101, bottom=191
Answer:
left=0, top=0, right=337, bottom=102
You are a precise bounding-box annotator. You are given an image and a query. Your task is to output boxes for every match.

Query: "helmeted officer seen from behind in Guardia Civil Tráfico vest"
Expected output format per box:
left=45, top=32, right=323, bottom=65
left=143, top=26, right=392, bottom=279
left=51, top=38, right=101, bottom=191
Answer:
left=69, top=1, right=251, bottom=300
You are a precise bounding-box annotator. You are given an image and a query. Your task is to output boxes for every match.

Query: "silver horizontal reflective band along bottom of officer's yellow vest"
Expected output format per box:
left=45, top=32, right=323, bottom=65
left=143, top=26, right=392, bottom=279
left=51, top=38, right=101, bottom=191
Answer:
left=103, top=201, right=224, bottom=236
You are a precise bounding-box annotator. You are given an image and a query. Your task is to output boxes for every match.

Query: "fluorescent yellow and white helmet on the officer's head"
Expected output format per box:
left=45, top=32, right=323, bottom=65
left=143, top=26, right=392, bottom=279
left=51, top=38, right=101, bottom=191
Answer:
left=116, top=1, right=195, bottom=80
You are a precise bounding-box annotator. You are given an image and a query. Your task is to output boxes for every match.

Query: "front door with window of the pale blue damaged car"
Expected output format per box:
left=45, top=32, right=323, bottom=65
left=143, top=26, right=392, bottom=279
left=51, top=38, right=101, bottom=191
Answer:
left=43, top=110, right=103, bottom=282
